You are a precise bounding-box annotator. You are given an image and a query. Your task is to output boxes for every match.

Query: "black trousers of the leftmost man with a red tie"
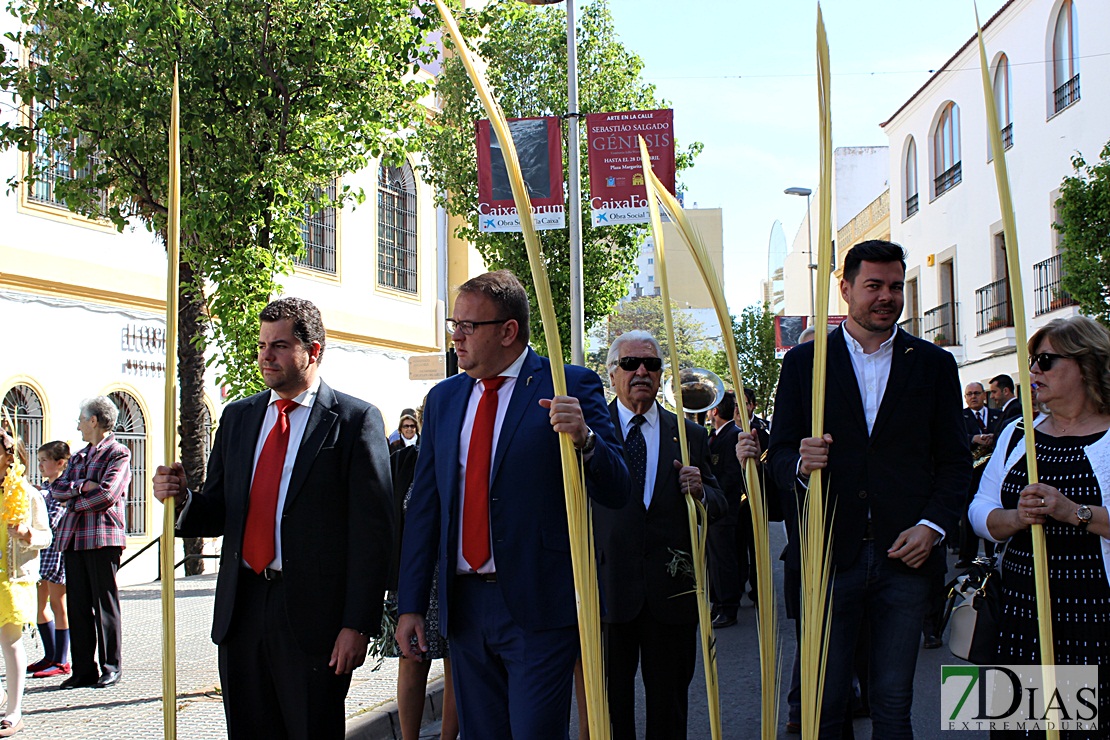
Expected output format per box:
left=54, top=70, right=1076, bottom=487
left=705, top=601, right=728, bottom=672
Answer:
left=219, top=568, right=351, bottom=740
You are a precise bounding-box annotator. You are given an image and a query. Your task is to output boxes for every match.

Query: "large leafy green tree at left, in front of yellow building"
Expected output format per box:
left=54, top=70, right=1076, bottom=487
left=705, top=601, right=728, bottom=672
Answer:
left=0, top=0, right=432, bottom=572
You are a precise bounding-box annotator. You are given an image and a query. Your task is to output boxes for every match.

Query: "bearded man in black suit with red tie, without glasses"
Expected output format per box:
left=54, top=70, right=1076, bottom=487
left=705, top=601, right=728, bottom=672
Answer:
left=154, top=298, right=393, bottom=740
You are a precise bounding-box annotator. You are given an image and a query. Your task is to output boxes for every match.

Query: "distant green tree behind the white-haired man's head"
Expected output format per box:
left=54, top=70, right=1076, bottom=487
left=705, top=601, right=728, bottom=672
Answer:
left=586, top=295, right=710, bottom=381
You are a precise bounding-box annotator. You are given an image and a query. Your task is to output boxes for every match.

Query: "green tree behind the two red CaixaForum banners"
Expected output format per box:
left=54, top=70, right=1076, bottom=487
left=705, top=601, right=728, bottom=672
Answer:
left=416, top=0, right=702, bottom=357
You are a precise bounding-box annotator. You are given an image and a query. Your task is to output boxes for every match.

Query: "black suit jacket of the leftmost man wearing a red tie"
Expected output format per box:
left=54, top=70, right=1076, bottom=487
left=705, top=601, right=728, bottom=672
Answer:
left=178, top=383, right=393, bottom=656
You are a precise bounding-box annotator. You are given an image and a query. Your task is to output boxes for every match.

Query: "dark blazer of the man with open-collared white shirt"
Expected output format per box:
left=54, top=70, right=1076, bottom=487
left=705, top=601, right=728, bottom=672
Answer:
left=769, top=326, right=971, bottom=569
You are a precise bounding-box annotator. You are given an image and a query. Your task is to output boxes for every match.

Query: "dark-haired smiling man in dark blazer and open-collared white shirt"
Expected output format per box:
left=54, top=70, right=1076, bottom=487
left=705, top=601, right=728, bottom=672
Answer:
left=770, top=241, right=971, bottom=740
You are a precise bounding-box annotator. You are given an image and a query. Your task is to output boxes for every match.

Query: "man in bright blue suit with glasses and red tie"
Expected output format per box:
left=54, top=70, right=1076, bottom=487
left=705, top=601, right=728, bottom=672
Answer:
left=396, top=271, right=629, bottom=740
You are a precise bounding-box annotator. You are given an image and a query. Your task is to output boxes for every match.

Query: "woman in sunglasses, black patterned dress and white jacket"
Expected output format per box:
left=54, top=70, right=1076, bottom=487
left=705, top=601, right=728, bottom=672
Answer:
left=970, top=316, right=1110, bottom=739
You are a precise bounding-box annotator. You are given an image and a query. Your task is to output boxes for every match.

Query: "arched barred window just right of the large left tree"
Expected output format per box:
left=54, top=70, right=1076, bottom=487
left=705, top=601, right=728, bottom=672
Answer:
left=377, top=162, right=417, bottom=293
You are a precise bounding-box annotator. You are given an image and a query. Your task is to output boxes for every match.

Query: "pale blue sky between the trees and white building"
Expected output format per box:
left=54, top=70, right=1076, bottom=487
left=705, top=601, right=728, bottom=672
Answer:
left=603, top=0, right=1006, bottom=313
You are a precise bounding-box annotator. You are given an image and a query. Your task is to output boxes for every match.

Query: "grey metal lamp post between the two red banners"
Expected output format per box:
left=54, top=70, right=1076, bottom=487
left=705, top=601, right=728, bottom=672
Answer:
left=566, top=0, right=586, bottom=365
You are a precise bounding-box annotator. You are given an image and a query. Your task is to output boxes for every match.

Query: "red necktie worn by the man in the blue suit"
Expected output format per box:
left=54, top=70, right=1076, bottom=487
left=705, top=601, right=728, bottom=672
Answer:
left=463, top=377, right=506, bottom=570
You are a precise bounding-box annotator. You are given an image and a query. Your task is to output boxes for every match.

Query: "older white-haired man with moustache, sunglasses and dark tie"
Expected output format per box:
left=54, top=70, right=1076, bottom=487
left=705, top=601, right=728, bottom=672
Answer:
left=594, top=331, right=728, bottom=740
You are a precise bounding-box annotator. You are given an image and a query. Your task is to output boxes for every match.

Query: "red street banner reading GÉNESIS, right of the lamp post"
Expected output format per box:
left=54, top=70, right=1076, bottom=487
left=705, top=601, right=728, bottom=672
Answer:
left=586, top=109, right=675, bottom=226
